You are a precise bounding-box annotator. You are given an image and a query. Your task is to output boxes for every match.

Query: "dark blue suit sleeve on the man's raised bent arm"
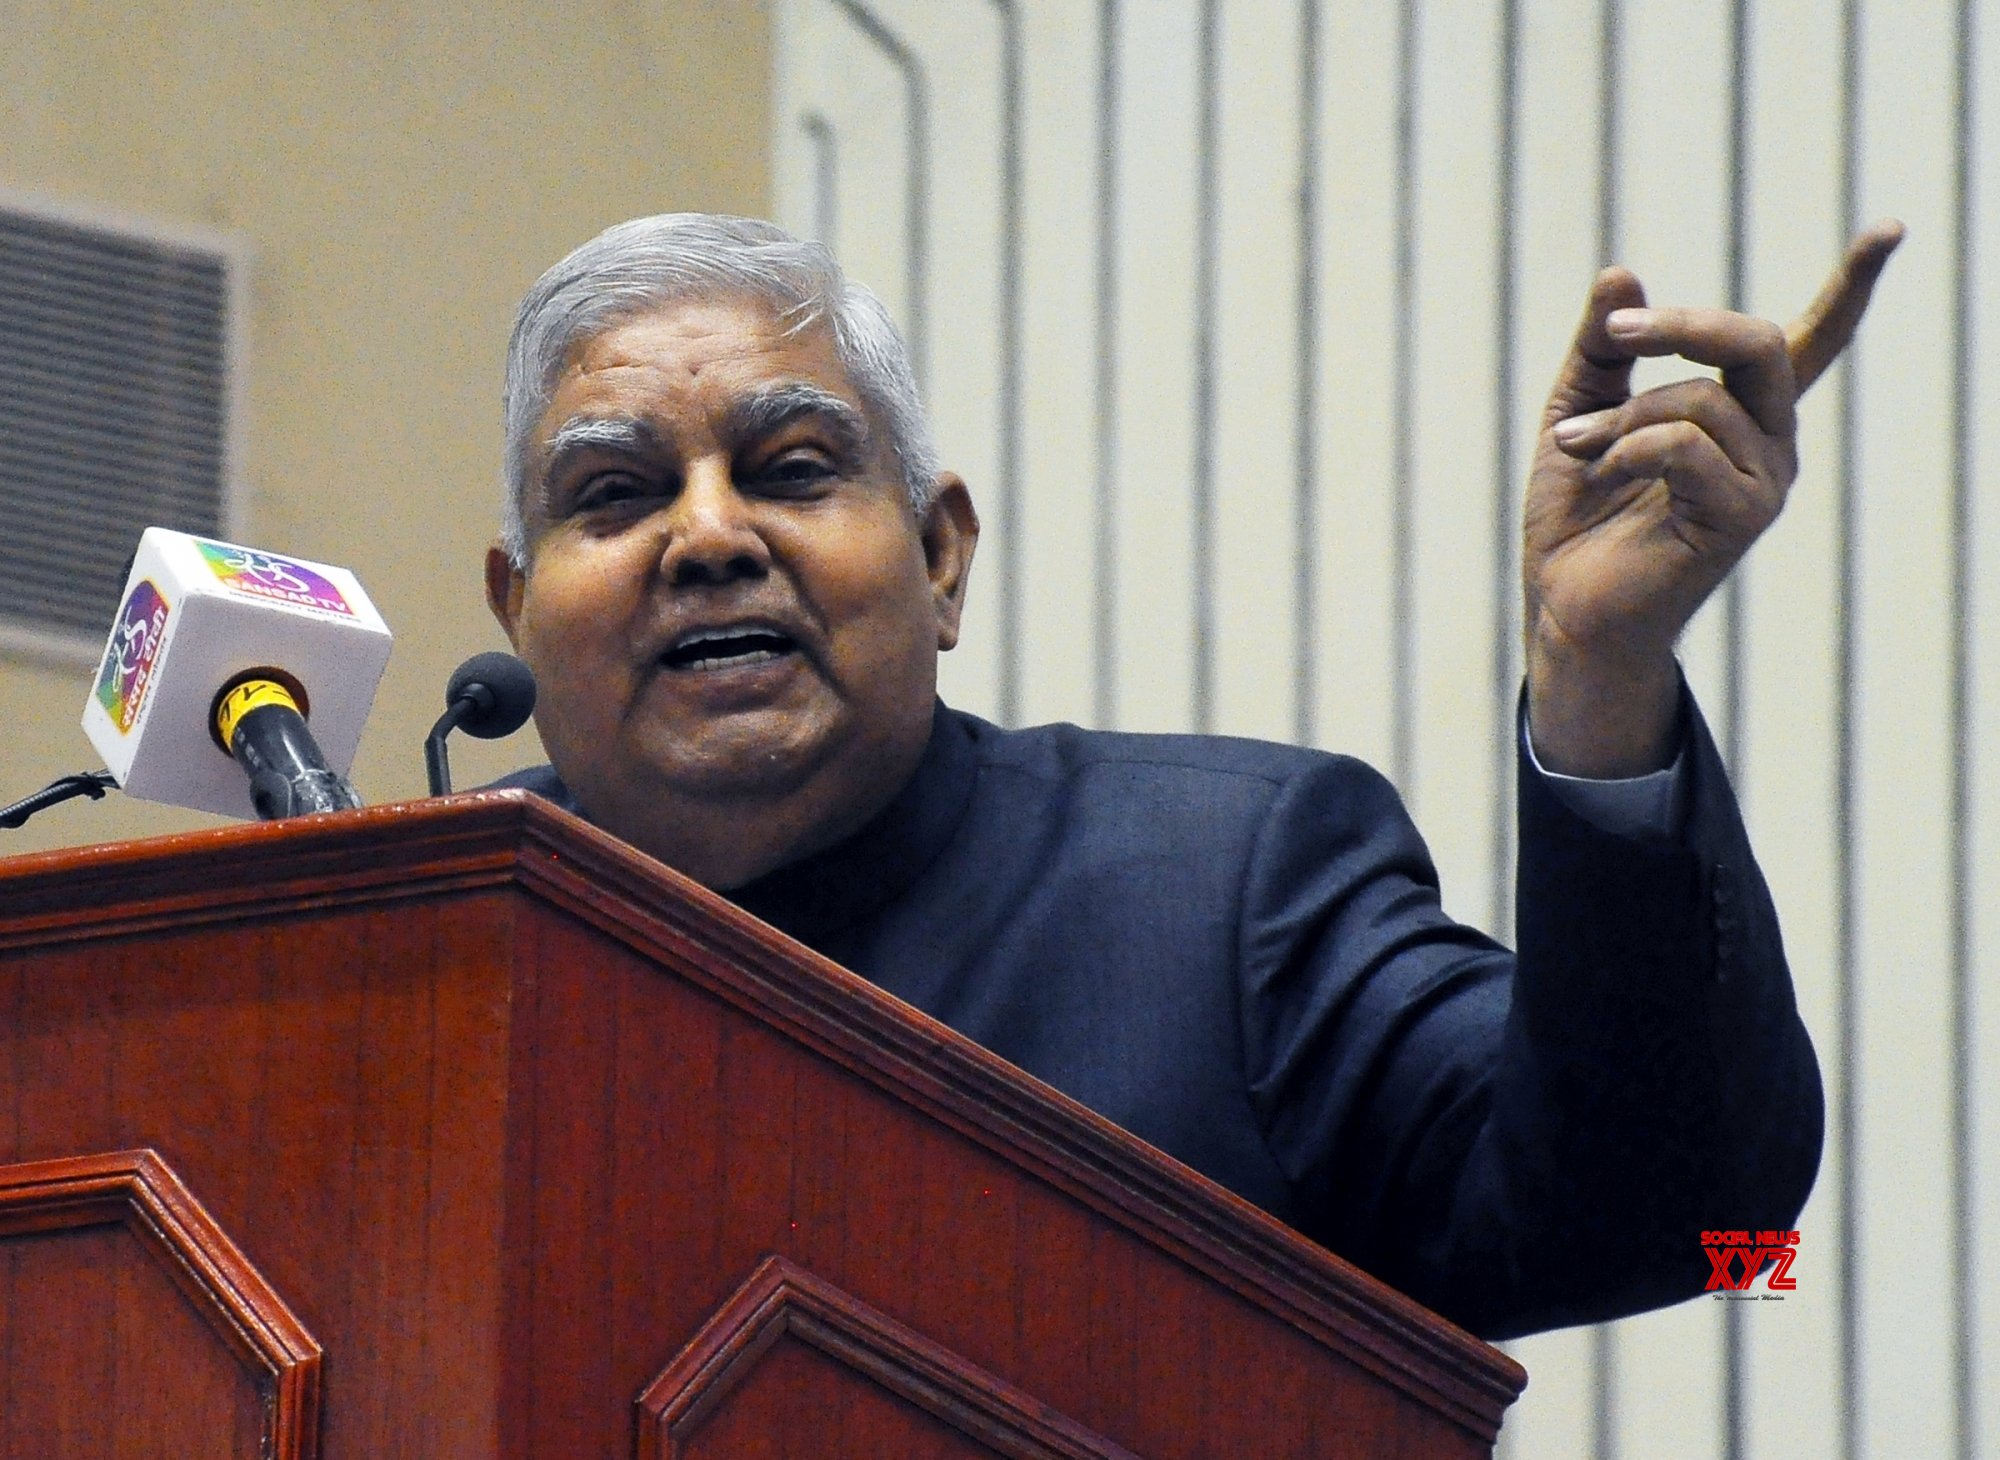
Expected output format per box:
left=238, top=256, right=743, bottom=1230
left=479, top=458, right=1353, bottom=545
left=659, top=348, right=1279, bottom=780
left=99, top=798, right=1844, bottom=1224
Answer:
left=1240, top=700, right=1824, bottom=1338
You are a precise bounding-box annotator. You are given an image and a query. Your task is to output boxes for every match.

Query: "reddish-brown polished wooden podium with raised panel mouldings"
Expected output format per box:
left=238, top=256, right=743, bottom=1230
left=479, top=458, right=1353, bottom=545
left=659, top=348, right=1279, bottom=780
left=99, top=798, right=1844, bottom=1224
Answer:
left=0, top=794, right=1526, bottom=1460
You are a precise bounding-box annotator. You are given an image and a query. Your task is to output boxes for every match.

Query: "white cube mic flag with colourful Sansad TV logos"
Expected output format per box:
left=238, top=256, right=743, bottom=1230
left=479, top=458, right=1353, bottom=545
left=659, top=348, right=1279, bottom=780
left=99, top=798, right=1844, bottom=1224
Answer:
left=84, top=528, right=390, bottom=816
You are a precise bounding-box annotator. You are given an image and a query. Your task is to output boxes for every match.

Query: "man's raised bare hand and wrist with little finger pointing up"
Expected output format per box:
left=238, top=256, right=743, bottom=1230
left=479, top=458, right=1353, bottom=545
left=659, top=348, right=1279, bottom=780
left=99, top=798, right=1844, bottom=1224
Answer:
left=1522, top=222, right=1902, bottom=776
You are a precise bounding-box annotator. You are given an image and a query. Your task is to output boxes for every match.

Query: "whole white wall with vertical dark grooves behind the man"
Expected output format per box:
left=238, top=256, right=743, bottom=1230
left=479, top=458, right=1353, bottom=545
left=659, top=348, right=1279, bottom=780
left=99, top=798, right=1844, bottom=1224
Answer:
left=778, top=0, right=2000, bottom=1460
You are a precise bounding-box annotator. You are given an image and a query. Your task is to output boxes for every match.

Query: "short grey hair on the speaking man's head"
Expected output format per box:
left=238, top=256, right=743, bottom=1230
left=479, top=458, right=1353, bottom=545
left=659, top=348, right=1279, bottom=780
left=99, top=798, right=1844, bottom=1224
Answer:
left=500, top=212, right=938, bottom=568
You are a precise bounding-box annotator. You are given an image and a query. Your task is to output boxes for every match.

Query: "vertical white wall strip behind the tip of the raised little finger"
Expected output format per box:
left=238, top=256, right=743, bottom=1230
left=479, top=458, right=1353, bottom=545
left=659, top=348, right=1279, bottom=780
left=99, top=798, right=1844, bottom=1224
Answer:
left=1852, top=0, right=1956, bottom=1456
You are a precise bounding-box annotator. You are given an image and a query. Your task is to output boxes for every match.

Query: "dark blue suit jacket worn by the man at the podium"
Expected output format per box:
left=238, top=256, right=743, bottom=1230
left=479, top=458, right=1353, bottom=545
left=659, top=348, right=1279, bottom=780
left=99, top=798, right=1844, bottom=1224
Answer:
left=496, top=706, right=1822, bottom=1336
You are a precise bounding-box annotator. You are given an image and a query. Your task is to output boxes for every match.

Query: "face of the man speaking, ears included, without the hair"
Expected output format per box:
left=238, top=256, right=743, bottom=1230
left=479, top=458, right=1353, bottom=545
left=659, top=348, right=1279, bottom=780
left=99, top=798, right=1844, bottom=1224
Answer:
left=488, top=298, right=978, bottom=886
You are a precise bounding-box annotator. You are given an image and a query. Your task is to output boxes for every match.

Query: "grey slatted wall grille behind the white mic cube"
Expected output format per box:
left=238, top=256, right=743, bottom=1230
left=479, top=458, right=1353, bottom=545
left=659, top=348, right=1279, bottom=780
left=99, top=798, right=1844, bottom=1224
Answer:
left=0, top=206, right=234, bottom=650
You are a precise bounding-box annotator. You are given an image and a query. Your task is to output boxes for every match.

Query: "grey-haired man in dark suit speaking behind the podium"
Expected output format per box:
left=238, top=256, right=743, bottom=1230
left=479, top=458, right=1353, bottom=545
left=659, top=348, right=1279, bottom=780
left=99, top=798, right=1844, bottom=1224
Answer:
left=486, top=216, right=1896, bottom=1336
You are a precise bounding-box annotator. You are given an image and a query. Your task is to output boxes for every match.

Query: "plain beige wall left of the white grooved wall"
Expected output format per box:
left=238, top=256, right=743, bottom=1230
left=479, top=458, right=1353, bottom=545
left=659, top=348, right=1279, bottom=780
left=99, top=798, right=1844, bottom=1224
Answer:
left=0, top=0, right=770, bottom=854
